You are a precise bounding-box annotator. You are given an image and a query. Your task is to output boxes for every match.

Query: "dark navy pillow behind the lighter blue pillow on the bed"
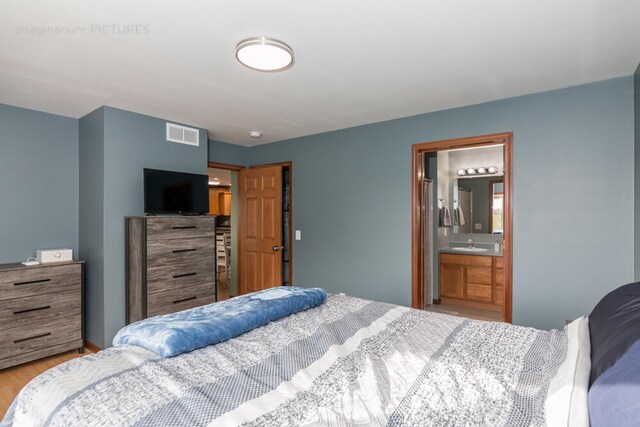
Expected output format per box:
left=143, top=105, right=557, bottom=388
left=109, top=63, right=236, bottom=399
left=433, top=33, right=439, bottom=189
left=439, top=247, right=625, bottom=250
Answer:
left=589, top=282, right=640, bottom=386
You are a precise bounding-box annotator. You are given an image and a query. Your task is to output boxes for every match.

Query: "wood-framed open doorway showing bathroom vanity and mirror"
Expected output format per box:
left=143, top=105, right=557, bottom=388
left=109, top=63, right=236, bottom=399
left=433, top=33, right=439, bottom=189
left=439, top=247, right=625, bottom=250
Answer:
left=411, top=132, right=513, bottom=323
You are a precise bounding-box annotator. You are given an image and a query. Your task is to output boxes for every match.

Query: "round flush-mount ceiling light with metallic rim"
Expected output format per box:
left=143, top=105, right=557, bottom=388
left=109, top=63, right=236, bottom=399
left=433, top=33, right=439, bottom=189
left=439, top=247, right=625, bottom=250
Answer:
left=236, top=37, right=294, bottom=72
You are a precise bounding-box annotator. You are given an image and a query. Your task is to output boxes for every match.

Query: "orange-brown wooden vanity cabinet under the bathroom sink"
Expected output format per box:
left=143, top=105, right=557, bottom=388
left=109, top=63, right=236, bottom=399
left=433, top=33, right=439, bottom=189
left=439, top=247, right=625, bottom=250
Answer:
left=439, top=253, right=504, bottom=309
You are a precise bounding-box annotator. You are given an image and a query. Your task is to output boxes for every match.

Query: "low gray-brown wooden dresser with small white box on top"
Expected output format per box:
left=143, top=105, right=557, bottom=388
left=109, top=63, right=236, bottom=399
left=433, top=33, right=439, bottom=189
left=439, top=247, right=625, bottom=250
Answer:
left=0, top=261, right=84, bottom=369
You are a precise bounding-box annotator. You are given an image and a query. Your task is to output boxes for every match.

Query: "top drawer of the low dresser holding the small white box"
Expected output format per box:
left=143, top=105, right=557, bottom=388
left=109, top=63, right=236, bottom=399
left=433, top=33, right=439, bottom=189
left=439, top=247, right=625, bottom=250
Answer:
left=0, top=264, right=82, bottom=301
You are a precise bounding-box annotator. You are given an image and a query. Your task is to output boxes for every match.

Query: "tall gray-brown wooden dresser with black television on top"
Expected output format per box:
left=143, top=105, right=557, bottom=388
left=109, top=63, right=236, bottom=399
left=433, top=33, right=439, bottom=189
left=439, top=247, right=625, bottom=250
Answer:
left=126, top=216, right=216, bottom=323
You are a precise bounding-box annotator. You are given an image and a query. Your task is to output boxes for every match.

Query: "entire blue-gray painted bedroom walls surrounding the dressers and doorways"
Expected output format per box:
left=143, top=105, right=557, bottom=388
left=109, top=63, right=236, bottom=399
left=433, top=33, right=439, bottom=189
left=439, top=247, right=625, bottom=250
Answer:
left=0, top=72, right=640, bottom=347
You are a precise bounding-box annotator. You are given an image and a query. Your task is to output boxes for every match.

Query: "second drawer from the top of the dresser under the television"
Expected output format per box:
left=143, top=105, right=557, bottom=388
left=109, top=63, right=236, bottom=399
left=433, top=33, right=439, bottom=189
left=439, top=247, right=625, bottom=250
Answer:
left=147, top=237, right=216, bottom=268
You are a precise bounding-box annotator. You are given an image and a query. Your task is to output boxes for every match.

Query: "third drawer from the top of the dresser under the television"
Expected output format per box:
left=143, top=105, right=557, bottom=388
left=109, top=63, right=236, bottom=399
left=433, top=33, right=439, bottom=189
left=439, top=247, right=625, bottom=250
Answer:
left=147, top=258, right=216, bottom=294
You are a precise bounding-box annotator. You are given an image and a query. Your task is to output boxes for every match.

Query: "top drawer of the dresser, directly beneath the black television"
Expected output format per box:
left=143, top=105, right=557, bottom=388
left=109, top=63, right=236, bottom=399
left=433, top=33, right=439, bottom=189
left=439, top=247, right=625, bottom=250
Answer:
left=147, top=216, right=216, bottom=241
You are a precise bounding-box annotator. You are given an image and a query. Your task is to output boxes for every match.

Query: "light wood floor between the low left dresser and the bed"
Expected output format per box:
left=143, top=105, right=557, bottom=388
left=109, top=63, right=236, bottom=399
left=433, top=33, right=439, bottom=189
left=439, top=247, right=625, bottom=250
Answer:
left=0, top=348, right=92, bottom=420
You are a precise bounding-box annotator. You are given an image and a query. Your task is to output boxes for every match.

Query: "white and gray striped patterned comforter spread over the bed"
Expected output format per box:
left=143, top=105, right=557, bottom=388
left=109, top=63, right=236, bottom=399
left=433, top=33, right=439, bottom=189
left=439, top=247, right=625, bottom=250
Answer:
left=2, top=295, right=589, bottom=426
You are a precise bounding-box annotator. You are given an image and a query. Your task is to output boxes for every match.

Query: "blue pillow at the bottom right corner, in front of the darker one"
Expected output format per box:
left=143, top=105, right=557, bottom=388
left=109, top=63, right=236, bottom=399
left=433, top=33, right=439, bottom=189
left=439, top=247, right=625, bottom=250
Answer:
left=589, top=341, right=640, bottom=427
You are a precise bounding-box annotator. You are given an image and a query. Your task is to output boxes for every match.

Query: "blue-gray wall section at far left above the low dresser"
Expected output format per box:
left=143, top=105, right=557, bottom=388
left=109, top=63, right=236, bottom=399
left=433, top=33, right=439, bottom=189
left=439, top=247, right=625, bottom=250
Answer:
left=0, top=104, right=78, bottom=263
